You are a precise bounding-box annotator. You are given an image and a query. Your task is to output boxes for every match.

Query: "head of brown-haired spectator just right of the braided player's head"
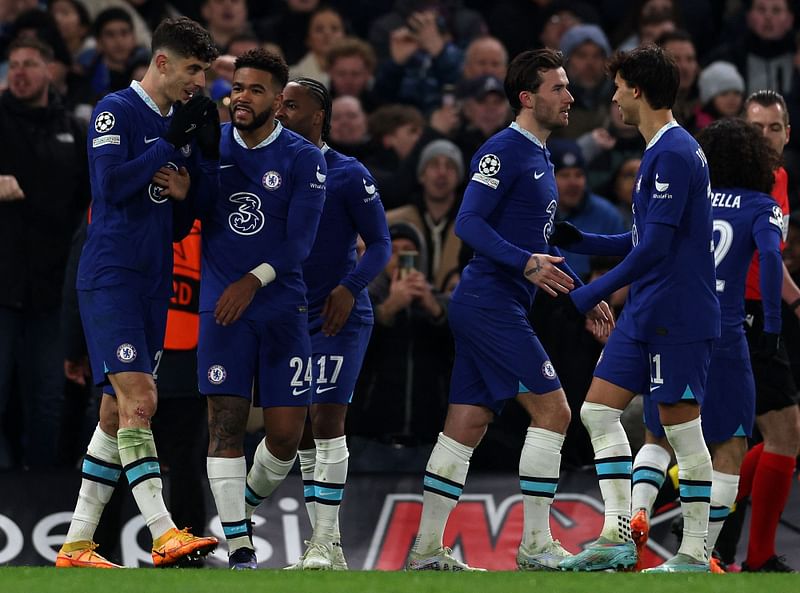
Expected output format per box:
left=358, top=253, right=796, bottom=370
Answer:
left=327, top=37, right=378, bottom=113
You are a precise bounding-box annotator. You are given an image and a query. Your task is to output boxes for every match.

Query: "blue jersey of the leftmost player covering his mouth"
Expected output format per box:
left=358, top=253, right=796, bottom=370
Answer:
left=78, top=81, right=203, bottom=298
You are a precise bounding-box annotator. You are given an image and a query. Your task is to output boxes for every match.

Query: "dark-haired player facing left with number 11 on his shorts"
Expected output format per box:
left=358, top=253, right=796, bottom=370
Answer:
left=554, top=45, right=720, bottom=572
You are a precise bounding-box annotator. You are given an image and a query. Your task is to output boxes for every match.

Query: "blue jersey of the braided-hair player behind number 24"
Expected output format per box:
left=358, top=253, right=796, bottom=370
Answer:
left=303, top=145, right=391, bottom=331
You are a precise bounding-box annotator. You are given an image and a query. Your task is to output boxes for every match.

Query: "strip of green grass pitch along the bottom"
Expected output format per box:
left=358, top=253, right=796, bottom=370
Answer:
left=0, top=567, right=800, bottom=593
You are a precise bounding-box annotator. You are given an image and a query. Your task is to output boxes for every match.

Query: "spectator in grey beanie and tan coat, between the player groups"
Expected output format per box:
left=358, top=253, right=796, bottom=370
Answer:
left=386, top=139, right=464, bottom=290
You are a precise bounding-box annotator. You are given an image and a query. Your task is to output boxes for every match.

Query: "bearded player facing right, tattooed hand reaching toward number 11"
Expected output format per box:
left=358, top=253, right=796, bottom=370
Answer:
left=408, top=50, right=613, bottom=571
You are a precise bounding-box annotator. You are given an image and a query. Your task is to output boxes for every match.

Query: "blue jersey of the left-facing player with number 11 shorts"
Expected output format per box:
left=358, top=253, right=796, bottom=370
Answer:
left=617, top=122, right=720, bottom=344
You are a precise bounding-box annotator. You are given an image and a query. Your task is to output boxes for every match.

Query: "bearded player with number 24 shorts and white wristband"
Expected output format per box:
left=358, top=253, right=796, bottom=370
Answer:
left=197, top=49, right=327, bottom=569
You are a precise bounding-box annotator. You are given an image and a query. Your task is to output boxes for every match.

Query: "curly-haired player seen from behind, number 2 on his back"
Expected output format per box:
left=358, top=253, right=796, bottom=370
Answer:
left=631, top=119, right=783, bottom=570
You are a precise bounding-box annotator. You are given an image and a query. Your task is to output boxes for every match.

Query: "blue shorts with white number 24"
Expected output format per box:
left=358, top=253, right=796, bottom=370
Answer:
left=197, top=312, right=311, bottom=408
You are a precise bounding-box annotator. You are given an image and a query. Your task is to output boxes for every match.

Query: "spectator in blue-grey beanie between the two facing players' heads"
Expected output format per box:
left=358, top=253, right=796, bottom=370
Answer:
left=553, top=25, right=614, bottom=138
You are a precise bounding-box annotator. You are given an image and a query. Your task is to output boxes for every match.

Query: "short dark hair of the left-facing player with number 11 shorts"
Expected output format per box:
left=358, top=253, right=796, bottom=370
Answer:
left=608, top=43, right=680, bottom=109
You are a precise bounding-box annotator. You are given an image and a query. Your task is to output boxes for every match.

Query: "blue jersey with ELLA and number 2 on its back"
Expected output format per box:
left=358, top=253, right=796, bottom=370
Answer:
left=711, top=188, right=783, bottom=340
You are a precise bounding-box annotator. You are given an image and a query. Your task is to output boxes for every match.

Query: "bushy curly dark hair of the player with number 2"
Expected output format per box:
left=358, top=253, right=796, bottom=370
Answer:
left=697, top=117, right=780, bottom=194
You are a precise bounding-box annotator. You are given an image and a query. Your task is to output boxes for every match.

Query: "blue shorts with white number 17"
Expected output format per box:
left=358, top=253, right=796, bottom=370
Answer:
left=311, top=323, right=372, bottom=404
